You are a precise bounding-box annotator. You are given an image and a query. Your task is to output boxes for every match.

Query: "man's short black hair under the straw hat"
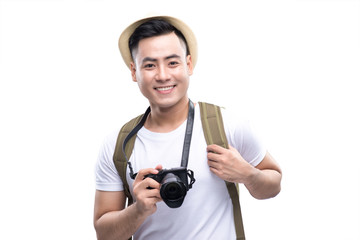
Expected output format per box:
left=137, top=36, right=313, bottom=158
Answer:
left=129, top=19, right=190, bottom=59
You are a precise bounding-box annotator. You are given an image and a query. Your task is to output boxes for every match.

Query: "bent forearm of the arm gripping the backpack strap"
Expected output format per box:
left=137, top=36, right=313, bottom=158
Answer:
left=244, top=168, right=281, bottom=199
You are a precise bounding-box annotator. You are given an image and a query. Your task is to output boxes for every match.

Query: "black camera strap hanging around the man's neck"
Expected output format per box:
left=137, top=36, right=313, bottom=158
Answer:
left=122, top=99, right=195, bottom=179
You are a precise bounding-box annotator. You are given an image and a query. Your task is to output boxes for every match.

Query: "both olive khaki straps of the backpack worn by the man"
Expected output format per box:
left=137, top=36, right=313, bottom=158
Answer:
left=113, top=102, right=245, bottom=240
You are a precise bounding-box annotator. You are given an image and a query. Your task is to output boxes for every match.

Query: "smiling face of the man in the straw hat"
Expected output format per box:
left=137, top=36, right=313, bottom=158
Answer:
left=131, top=33, right=193, bottom=108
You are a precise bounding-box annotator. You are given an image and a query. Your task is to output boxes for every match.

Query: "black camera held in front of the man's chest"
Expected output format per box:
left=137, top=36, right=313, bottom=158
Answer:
left=145, top=167, right=195, bottom=208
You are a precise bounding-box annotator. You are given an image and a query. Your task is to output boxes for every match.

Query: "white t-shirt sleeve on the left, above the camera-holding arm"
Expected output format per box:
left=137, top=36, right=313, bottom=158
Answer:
left=95, top=132, right=124, bottom=191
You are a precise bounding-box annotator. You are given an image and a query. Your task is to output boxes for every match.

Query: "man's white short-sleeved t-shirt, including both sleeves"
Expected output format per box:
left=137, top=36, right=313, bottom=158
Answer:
left=96, top=104, right=266, bottom=240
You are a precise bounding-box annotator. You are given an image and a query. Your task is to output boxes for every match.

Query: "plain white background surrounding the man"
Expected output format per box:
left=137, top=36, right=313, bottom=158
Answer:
left=0, top=0, right=360, bottom=240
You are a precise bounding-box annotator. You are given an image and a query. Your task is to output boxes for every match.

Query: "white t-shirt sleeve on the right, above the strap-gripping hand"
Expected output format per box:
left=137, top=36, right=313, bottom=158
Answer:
left=221, top=109, right=266, bottom=166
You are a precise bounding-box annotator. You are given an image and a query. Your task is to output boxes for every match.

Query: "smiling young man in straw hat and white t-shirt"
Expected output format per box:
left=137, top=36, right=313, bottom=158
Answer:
left=94, top=16, right=281, bottom=240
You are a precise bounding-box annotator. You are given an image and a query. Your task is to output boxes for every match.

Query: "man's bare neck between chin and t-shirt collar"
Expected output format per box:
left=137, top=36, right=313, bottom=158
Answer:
left=144, top=98, right=189, bottom=132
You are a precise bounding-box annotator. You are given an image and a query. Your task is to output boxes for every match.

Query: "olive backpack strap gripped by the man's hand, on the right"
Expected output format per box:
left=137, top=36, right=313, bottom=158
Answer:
left=199, top=102, right=245, bottom=240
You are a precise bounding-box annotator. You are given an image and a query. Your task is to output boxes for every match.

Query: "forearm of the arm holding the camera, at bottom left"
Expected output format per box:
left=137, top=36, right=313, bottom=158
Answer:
left=95, top=204, right=146, bottom=240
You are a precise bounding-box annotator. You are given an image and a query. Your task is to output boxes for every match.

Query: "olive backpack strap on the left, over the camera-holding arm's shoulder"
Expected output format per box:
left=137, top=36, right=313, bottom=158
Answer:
left=113, top=114, right=144, bottom=206
